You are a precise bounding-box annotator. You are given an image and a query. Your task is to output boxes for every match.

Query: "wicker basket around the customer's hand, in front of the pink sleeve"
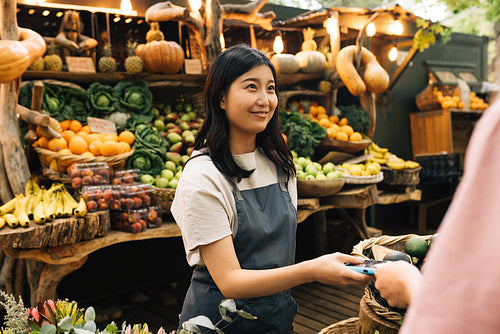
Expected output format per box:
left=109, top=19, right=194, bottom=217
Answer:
left=351, top=234, right=432, bottom=332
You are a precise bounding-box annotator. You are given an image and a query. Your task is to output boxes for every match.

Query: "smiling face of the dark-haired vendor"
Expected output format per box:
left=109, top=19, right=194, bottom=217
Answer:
left=220, top=65, right=278, bottom=148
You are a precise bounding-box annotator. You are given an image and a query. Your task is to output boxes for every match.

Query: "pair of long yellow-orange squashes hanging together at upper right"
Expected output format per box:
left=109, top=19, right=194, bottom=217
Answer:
left=335, top=45, right=390, bottom=96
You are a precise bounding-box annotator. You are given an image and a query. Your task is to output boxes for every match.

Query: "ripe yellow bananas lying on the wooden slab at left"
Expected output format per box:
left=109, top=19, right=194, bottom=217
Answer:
left=0, top=179, right=87, bottom=228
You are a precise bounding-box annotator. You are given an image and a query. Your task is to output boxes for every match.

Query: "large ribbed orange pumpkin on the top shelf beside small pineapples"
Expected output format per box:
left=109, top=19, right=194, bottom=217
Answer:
left=136, top=41, right=184, bottom=74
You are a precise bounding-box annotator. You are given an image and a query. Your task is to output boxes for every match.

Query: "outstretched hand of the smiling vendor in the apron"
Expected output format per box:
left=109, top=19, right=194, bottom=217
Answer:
left=310, top=253, right=373, bottom=286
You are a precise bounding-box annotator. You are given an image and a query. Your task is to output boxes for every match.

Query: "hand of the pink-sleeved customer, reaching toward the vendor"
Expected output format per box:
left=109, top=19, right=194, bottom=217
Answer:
left=375, top=261, right=422, bottom=308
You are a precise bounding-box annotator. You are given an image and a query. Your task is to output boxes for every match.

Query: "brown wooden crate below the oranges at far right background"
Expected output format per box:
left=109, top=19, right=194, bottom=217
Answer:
left=410, top=109, right=453, bottom=157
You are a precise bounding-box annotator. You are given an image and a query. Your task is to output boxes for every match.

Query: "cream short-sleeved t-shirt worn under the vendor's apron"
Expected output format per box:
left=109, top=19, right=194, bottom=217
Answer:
left=171, top=149, right=297, bottom=266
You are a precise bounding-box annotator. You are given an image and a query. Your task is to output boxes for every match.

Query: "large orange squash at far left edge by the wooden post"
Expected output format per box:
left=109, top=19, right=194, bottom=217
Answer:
left=0, top=28, right=46, bottom=83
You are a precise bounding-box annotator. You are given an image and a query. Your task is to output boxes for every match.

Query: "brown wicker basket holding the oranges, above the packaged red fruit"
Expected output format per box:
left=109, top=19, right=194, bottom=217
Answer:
left=34, top=147, right=134, bottom=183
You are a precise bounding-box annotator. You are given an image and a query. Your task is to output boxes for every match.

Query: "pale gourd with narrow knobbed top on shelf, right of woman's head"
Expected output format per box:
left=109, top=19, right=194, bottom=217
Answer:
left=295, top=28, right=326, bottom=73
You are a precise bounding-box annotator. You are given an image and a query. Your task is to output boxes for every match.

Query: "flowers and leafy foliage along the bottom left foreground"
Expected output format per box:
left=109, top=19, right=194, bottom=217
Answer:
left=0, top=290, right=257, bottom=334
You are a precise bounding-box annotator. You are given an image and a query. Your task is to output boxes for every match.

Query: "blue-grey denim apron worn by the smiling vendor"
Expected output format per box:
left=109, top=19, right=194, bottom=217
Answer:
left=179, top=168, right=297, bottom=334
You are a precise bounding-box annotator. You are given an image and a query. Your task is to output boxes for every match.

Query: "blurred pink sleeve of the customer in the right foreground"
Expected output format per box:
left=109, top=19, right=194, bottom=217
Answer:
left=400, top=100, right=500, bottom=334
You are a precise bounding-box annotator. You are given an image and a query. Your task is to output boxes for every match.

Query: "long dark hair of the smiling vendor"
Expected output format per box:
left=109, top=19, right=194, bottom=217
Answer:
left=194, top=45, right=295, bottom=182
